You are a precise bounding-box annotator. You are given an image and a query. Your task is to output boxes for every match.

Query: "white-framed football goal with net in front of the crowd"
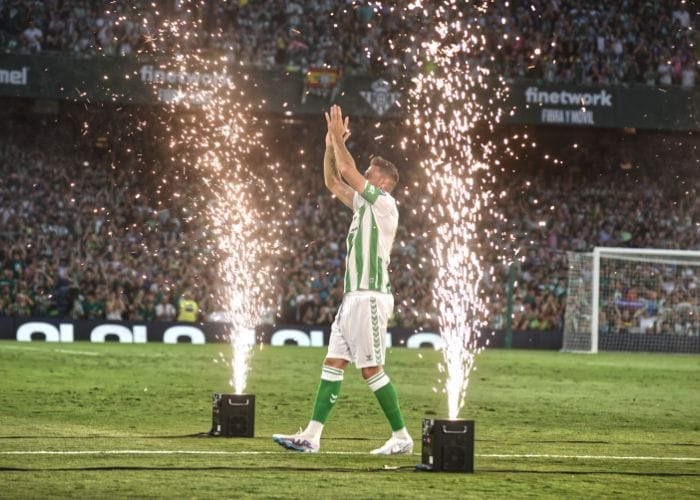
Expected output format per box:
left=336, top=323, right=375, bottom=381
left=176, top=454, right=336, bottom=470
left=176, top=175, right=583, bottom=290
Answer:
left=563, top=247, right=700, bottom=353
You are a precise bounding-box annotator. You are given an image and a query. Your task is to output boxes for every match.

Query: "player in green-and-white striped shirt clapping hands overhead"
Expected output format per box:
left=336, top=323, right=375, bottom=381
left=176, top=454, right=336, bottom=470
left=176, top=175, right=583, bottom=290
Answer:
left=272, top=105, right=413, bottom=455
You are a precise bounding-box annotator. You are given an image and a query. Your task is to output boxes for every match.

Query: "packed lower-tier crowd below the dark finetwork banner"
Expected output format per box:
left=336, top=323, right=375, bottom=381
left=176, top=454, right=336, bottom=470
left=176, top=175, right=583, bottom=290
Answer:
left=0, top=107, right=700, bottom=330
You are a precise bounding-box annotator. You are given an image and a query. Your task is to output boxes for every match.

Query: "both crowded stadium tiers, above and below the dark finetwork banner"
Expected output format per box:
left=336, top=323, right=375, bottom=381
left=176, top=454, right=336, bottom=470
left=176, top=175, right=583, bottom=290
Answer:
left=0, top=0, right=700, bottom=336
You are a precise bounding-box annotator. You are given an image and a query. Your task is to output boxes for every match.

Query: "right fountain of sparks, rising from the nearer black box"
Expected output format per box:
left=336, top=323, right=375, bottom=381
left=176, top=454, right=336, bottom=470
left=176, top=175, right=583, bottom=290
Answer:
left=407, top=0, right=505, bottom=419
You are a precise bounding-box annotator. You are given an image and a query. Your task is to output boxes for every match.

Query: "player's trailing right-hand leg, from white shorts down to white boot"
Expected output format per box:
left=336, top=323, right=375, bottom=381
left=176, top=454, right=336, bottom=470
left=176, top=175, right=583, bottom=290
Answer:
left=353, top=294, right=413, bottom=454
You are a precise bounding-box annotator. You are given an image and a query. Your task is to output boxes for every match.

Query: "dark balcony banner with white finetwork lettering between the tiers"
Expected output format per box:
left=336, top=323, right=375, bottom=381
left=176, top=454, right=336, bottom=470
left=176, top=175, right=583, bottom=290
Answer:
left=0, top=54, right=700, bottom=130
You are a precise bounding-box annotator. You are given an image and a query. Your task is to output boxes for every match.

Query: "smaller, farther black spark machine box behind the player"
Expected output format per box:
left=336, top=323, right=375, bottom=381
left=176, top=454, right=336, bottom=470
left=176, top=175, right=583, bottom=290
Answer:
left=209, top=393, right=255, bottom=437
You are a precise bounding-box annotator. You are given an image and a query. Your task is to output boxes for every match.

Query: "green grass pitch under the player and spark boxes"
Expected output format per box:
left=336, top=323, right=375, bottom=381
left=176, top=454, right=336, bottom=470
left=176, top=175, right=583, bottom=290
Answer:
left=0, top=342, right=700, bottom=499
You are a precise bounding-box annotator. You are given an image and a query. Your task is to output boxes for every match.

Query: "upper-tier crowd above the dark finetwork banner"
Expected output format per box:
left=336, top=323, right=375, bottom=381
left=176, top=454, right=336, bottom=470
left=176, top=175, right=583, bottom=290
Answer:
left=0, top=0, right=700, bottom=88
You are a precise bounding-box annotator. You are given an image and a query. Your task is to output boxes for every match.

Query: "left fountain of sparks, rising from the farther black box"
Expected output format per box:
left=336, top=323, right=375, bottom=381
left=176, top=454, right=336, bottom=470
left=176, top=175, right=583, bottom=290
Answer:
left=141, top=1, right=286, bottom=394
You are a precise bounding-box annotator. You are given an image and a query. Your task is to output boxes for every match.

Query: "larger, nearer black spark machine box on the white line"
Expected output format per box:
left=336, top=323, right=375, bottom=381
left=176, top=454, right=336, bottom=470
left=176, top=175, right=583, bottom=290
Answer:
left=420, top=418, right=474, bottom=472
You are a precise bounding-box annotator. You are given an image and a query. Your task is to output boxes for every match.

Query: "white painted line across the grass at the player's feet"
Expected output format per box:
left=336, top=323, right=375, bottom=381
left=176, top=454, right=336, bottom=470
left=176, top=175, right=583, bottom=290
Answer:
left=0, top=450, right=700, bottom=462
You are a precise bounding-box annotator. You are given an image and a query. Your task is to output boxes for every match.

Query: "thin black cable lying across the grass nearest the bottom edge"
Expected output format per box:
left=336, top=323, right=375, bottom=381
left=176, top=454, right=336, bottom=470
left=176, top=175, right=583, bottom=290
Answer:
left=0, top=465, right=700, bottom=477
